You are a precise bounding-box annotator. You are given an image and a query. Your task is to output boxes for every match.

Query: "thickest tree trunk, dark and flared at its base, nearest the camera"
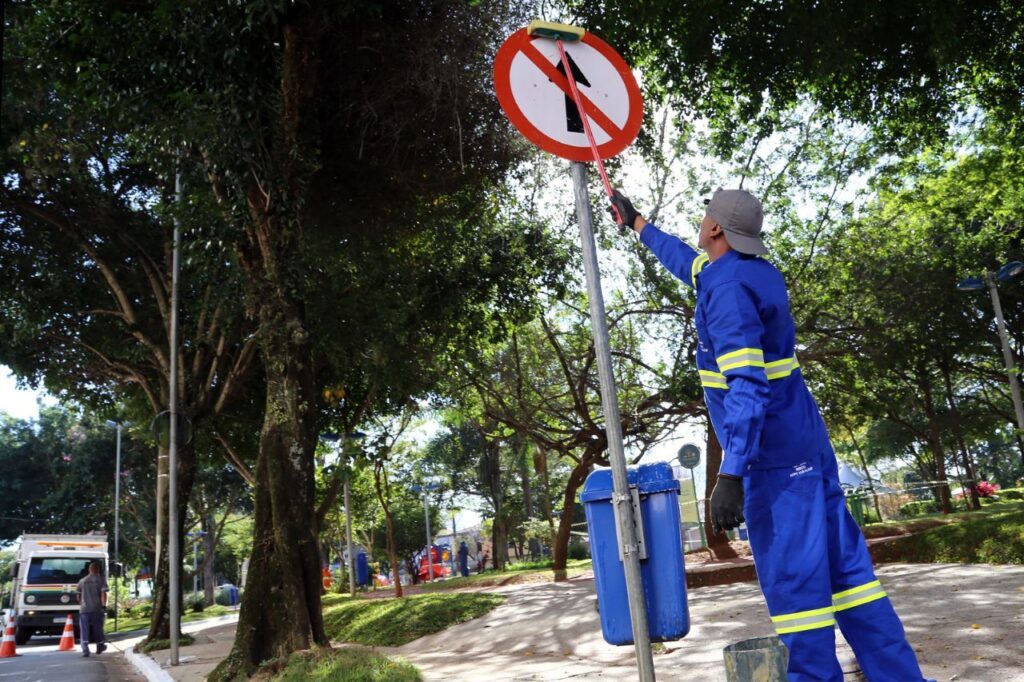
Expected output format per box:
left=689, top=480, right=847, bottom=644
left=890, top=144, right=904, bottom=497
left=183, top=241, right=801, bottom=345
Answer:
left=209, top=278, right=328, bottom=681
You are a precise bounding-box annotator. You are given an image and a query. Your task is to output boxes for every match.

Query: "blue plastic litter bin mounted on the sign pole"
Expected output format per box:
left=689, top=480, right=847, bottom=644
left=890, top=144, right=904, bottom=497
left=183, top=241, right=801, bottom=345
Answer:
left=580, top=462, right=690, bottom=645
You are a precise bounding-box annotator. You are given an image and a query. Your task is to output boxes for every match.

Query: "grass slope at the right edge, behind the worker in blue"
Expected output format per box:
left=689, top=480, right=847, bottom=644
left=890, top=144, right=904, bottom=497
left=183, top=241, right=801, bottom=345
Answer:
left=865, top=501, right=1024, bottom=563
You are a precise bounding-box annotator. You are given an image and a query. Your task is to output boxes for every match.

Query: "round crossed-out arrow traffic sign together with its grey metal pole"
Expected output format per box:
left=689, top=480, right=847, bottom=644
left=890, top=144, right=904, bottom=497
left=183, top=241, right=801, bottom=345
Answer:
left=495, top=22, right=654, bottom=682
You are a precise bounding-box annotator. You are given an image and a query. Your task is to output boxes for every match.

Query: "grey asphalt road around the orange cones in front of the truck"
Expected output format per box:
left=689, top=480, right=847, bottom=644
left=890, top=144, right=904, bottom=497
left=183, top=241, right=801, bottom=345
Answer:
left=0, top=637, right=145, bottom=682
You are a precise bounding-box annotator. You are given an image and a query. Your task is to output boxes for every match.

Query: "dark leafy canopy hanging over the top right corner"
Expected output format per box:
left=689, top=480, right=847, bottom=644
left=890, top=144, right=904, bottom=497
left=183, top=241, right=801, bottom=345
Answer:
left=567, top=0, right=1024, bottom=147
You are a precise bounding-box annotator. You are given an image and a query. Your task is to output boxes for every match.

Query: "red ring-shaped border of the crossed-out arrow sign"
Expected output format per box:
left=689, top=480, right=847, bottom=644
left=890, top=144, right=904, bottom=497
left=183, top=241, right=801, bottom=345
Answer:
left=495, top=29, right=643, bottom=161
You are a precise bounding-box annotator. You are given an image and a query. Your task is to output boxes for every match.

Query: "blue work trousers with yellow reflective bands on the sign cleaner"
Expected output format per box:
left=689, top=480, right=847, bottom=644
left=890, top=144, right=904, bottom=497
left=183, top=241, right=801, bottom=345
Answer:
left=744, top=445, right=923, bottom=682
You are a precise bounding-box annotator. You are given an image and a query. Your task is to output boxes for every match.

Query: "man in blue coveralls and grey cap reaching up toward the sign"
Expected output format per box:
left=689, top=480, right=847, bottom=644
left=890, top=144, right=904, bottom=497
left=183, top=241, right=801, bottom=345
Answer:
left=609, top=188, right=923, bottom=682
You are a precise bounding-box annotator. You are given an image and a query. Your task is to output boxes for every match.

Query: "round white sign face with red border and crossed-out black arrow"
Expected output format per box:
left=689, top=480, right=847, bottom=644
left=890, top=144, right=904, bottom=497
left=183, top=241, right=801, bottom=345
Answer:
left=495, top=29, right=643, bottom=161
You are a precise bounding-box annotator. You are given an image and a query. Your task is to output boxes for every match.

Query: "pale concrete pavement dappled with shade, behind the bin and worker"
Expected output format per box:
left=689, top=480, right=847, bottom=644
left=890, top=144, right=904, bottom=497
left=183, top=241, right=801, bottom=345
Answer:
left=132, top=564, right=1024, bottom=682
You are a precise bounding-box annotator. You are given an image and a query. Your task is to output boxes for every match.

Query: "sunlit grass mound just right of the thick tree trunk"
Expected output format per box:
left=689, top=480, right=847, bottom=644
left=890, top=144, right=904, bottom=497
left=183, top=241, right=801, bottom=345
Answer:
left=323, top=593, right=505, bottom=643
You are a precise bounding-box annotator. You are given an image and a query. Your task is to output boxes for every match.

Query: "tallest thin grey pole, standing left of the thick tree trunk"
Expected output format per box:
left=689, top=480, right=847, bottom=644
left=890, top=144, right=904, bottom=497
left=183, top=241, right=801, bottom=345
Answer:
left=167, top=170, right=184, bottom=666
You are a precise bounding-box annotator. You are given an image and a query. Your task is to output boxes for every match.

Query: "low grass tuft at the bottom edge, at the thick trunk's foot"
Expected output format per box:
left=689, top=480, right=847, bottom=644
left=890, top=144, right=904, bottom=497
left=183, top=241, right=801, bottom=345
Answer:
left=268, top=649, right=423, bottom=682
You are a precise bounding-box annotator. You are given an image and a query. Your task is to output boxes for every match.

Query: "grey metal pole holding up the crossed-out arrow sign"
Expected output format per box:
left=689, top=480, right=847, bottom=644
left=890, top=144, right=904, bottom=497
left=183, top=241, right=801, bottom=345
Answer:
left=572, top=161, right=654, bottom=682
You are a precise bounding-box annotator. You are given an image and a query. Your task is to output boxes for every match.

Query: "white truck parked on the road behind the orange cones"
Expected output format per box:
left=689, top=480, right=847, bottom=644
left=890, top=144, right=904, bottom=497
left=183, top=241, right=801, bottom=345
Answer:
left=11, top=535, right=106, bottom=644
